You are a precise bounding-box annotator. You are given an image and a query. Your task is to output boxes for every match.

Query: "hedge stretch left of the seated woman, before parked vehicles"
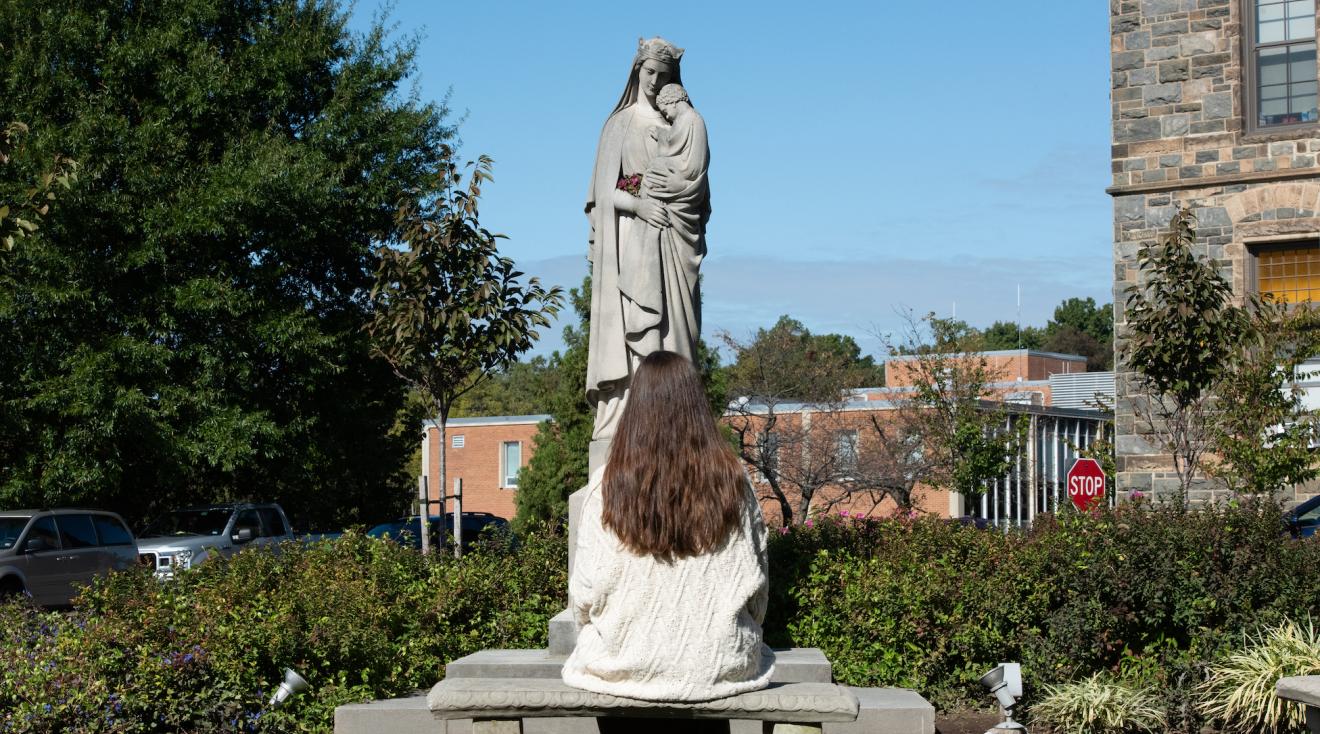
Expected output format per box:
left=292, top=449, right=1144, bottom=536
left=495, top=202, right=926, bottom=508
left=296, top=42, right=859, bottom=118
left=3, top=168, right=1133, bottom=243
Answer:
left=0, top=533, right=566, bottom=733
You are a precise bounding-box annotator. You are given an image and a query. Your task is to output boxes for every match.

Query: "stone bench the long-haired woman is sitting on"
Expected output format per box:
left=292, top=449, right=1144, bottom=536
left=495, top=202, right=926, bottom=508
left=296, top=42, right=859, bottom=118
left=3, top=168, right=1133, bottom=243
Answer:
left=426, top=677, right=858, bottom=734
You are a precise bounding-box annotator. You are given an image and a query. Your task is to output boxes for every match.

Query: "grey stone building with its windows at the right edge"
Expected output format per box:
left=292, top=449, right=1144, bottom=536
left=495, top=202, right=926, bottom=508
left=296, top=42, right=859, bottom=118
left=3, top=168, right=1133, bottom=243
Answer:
left=1107, top=0, right=1320, bottom=500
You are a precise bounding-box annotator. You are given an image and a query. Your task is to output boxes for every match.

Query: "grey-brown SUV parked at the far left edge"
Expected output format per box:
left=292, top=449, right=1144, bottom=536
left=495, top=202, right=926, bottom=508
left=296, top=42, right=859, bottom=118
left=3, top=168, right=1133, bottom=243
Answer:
left=0, top=510, right=137, bottom=606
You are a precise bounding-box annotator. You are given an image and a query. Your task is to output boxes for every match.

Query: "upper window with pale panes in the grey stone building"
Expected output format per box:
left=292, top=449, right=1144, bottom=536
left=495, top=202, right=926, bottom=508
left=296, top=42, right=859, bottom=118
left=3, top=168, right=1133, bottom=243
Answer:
left=1246, top=0, right=1320, bottom=129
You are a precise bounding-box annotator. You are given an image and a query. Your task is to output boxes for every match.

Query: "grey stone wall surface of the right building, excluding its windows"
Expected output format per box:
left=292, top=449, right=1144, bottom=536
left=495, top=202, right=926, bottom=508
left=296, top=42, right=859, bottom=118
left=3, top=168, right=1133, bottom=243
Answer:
left=1109, top=0, right=1320, bottom=500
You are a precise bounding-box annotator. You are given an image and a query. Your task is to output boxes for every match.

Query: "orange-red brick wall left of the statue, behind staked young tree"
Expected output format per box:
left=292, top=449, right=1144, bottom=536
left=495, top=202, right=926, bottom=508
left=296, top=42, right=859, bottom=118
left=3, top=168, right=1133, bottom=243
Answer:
left=426, top=420, right=539, bottom=520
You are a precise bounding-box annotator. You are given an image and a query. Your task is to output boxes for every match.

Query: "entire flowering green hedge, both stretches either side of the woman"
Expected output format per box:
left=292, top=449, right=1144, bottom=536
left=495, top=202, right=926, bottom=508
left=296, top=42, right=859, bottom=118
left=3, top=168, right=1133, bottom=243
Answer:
left=0, top=506, right=1320, bottom=731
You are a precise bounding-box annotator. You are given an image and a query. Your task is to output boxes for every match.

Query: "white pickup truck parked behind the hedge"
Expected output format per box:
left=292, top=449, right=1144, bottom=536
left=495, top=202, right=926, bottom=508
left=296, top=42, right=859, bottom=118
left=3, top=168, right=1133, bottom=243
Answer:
left=137, top=503, right=293, bottom=578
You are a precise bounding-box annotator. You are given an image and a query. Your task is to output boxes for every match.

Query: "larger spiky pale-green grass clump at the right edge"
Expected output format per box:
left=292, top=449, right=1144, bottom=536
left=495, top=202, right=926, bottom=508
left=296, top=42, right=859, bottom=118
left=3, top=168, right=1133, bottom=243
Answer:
left=1197, top=620, right=1320, bottom=731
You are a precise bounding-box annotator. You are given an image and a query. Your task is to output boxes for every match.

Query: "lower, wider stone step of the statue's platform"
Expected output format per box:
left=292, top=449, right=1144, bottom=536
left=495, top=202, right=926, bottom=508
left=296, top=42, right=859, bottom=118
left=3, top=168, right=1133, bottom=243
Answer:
left=334, top=688, right=935, bottom=734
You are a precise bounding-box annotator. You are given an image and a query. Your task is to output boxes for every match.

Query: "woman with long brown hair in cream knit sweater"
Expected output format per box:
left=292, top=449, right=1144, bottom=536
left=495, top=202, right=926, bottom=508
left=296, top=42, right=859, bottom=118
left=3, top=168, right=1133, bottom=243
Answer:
left=562, top=351, right=775, bottom=702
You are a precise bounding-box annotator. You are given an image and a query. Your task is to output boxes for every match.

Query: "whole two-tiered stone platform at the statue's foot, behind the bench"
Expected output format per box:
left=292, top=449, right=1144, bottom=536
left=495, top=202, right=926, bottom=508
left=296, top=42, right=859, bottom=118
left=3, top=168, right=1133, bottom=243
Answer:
left=334, top=648, right=935, bottom=734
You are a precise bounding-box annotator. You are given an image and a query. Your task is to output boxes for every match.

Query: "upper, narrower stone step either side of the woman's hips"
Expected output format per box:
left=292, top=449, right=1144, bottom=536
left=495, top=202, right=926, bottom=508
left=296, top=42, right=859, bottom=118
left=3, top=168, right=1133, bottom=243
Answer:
left=445, top=647, right=834, bottom=683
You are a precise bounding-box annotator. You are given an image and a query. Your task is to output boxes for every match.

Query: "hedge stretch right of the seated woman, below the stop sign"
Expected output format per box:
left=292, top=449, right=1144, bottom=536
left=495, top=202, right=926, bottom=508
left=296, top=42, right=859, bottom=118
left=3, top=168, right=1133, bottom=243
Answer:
left=766, top=504, right=1320, bottom=712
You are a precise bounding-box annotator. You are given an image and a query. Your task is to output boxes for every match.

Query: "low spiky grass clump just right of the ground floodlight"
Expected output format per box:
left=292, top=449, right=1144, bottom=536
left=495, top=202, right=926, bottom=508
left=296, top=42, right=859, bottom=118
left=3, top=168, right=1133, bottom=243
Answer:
left=1031, top=673, right=1164, bottom=734
